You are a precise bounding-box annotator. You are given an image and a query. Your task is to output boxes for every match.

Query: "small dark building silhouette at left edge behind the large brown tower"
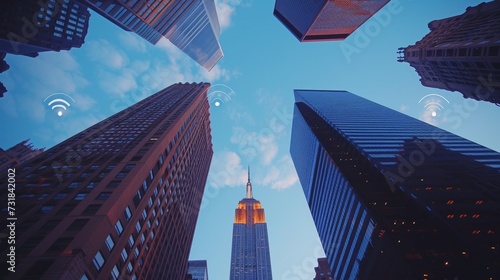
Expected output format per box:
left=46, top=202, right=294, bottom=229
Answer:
left=0, top=139, right=45, bottom=171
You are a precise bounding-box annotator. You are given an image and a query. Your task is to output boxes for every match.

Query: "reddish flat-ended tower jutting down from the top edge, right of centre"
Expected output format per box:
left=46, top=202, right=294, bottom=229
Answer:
left=274, top=0, right=389, bottom=42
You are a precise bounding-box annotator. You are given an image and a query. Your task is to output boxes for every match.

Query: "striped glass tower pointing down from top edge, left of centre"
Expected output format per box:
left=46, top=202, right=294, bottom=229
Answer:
left=79, top=0, right=223, bottom=70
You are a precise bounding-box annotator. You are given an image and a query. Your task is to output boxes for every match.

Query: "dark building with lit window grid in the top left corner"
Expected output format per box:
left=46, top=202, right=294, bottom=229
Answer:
left=0, top=0, right=90, bottom=57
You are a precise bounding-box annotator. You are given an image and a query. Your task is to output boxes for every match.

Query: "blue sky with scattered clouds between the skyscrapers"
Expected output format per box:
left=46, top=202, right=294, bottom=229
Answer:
left=0, top=0, right=500, bottom=280
